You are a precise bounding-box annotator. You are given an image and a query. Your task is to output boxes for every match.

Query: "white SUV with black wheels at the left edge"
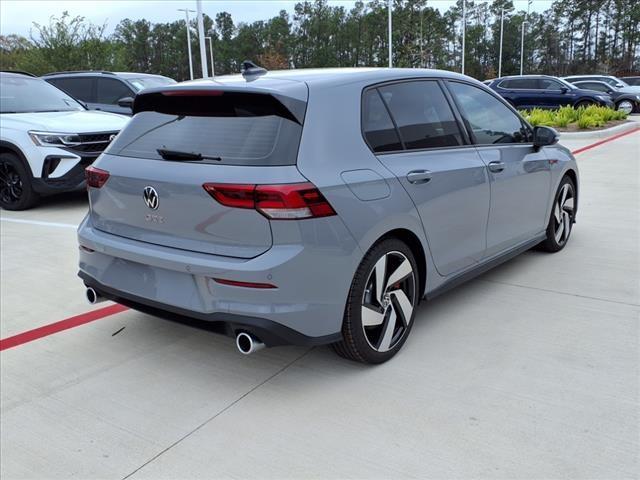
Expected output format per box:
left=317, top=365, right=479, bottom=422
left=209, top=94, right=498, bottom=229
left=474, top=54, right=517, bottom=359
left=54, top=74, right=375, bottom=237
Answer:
left=0, top=72, right=129, bottom=210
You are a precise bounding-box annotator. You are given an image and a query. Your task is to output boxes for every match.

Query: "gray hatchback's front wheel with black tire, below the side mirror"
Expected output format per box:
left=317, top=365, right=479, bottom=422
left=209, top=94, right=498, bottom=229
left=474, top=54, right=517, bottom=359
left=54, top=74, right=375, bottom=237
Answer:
left=539, top=176, right=577, bottom=253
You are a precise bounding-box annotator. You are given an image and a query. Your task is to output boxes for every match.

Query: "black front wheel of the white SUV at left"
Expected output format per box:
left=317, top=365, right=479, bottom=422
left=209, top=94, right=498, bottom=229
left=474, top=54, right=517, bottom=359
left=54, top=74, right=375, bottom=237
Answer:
left=0, top=153, right=40, bottom=210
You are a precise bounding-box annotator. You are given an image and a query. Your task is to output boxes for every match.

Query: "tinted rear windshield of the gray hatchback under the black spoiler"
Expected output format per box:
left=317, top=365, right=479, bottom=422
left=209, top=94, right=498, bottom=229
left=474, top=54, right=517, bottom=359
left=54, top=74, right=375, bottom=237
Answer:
left=107, top=91, right=305, bottom=166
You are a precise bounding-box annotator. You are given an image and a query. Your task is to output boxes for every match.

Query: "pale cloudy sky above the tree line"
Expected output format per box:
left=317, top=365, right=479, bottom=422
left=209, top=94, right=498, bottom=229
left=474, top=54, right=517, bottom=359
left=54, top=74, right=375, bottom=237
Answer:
left=0, top=0, right=551, bottom=37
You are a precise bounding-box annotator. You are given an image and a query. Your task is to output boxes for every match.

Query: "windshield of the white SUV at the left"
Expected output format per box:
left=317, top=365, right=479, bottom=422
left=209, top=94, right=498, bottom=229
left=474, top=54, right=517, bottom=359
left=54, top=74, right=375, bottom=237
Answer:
left=0, top=75, right=84, bottom=113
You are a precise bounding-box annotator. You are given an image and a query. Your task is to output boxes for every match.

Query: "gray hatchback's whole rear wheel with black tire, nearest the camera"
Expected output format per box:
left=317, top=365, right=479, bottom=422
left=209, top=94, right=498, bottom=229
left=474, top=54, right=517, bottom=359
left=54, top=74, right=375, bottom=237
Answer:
left=333, top=238, right=420, bottom=364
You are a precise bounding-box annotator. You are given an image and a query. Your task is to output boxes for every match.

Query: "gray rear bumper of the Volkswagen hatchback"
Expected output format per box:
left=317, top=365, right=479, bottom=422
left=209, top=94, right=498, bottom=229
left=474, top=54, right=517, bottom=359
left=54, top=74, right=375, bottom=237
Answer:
left=78, top=217, right=362, bottom=345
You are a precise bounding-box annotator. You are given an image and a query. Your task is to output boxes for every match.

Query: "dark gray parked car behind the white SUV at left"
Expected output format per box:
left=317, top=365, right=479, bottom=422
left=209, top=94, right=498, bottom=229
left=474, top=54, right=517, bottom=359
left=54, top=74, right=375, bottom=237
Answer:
left=42, top=70, right=176, bottom=115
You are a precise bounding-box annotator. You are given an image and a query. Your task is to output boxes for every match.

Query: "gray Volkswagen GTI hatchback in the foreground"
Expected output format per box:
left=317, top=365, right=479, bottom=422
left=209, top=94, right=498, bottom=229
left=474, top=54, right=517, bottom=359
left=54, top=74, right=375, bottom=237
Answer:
left=78, top=68, right=578, bottom=363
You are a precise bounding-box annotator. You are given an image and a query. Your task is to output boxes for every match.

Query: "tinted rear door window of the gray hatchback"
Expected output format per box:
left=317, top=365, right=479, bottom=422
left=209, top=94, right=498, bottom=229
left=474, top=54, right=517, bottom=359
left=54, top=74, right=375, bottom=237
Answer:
left=378, top=80, right=463, bottom=150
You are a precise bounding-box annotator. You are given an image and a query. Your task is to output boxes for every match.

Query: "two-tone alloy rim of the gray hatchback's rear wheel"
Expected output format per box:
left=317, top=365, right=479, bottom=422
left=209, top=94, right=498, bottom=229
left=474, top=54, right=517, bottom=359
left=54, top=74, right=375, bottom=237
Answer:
left=361, top=251, right=416, bottom=352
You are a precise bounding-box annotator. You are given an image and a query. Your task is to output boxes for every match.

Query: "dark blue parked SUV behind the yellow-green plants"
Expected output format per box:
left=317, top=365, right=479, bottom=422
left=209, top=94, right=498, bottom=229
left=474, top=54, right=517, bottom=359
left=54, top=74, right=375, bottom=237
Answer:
left=489, top=75, right=614, bottom=110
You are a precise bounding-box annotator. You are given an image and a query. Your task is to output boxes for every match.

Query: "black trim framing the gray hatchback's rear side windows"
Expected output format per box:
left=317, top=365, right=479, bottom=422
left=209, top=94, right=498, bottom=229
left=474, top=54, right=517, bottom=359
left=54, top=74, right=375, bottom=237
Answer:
left=360, top=77, right=474, bottom=156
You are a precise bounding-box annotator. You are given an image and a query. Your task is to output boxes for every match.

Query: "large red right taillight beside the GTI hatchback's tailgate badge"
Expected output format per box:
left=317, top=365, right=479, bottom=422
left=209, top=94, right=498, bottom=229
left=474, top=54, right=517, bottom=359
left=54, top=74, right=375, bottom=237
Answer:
left=203, top=182, right=336, bottom=220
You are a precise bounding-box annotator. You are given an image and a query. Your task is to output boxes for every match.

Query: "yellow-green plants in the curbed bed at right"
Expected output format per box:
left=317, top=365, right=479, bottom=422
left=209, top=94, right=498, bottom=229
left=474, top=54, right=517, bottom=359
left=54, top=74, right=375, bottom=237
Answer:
left=521, top=105, right=627, bottom=129
